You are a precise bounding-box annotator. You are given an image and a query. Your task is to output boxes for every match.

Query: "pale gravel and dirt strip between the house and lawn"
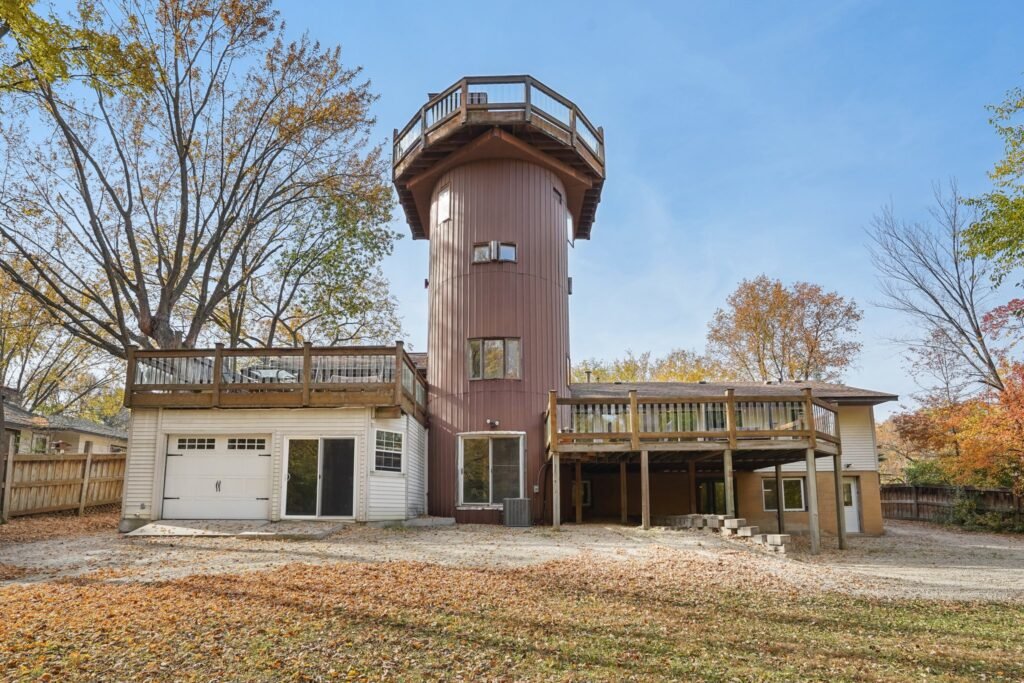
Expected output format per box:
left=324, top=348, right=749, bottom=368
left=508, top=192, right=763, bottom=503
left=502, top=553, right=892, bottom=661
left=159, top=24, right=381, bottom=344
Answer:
left=0, top=511, right=1024, bottom=601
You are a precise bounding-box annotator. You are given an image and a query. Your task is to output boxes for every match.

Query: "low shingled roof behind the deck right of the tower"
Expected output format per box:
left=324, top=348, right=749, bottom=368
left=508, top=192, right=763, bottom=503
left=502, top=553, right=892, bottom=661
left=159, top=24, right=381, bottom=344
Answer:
left=569, top=382, right=899, bottom=405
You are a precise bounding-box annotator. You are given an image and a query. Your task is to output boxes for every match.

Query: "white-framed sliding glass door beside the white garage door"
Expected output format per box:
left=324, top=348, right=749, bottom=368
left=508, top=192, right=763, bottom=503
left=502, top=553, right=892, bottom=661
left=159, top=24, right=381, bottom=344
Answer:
left=285, top=438, right=355, bottom=517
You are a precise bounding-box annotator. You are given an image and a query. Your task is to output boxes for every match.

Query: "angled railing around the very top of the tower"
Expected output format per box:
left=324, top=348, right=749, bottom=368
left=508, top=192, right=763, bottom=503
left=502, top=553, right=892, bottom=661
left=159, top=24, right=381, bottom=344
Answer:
left=392, top=76, right=604, bottom=168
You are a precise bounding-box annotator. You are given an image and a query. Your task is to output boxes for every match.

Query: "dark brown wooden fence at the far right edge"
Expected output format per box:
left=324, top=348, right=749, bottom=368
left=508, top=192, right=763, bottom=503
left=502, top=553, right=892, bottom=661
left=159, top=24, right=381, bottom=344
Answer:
left=882, top=484, right=1024, bottom=524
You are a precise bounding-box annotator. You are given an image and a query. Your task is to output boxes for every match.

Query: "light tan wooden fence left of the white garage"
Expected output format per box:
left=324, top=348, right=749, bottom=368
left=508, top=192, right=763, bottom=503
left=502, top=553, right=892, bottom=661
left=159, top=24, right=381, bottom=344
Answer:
left=2, top=453, right=127, bottom=520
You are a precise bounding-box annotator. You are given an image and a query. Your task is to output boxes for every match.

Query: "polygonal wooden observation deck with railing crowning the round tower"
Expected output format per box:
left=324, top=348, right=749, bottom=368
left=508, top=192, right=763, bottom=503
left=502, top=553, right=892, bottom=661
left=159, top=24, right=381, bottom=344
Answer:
left=392, top=76, right=604, bottom=240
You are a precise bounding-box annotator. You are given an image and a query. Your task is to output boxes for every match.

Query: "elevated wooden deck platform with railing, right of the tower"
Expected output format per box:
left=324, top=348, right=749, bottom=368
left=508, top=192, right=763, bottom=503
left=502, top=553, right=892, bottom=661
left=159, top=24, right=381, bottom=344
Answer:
left=544, top=385, right=841, bottom=470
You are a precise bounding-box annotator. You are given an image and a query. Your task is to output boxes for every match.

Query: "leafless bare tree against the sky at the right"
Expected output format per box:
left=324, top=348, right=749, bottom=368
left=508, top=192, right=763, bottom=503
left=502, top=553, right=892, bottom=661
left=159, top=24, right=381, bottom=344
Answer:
left=869, top=183, right=1004, bottom=391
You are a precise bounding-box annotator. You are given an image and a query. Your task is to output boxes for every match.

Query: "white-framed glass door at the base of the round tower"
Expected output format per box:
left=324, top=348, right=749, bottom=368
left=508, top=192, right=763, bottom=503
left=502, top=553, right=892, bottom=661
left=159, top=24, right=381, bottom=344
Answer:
left=459, top=434, right=523, bottom=505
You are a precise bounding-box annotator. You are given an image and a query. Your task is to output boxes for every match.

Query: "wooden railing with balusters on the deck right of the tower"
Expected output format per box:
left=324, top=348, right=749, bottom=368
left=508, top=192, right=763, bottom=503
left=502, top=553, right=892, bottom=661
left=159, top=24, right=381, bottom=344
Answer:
left=544, top=391, right=840, bottom=452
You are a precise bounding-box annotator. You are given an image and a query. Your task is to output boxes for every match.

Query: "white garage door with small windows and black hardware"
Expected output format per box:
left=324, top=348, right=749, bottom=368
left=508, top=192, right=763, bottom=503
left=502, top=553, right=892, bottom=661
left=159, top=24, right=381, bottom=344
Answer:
left=163, top=434, right=270, bottom=519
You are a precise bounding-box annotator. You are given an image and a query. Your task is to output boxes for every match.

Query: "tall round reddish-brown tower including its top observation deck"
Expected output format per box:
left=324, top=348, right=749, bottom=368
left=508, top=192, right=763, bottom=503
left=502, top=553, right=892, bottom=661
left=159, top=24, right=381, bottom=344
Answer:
left=393, top=76, right=604, bottom=522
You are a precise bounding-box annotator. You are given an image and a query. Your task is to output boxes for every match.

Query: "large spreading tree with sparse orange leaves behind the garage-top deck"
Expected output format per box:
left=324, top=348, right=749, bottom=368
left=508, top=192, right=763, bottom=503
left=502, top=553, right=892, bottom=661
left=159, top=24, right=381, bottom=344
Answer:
left=0, top=0, right=390, bottom=355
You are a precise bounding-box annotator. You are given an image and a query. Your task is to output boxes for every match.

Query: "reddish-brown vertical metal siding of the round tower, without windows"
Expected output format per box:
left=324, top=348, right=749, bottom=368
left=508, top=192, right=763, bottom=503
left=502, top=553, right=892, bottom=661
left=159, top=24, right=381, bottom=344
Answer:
left=427, top=160, right=569, bottom=521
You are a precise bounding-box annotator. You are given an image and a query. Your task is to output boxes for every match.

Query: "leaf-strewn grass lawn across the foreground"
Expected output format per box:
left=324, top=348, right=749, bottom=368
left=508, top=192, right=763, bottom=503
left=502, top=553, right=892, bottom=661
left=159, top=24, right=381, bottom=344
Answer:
left=0, top=551, right=1024, bottom=681
